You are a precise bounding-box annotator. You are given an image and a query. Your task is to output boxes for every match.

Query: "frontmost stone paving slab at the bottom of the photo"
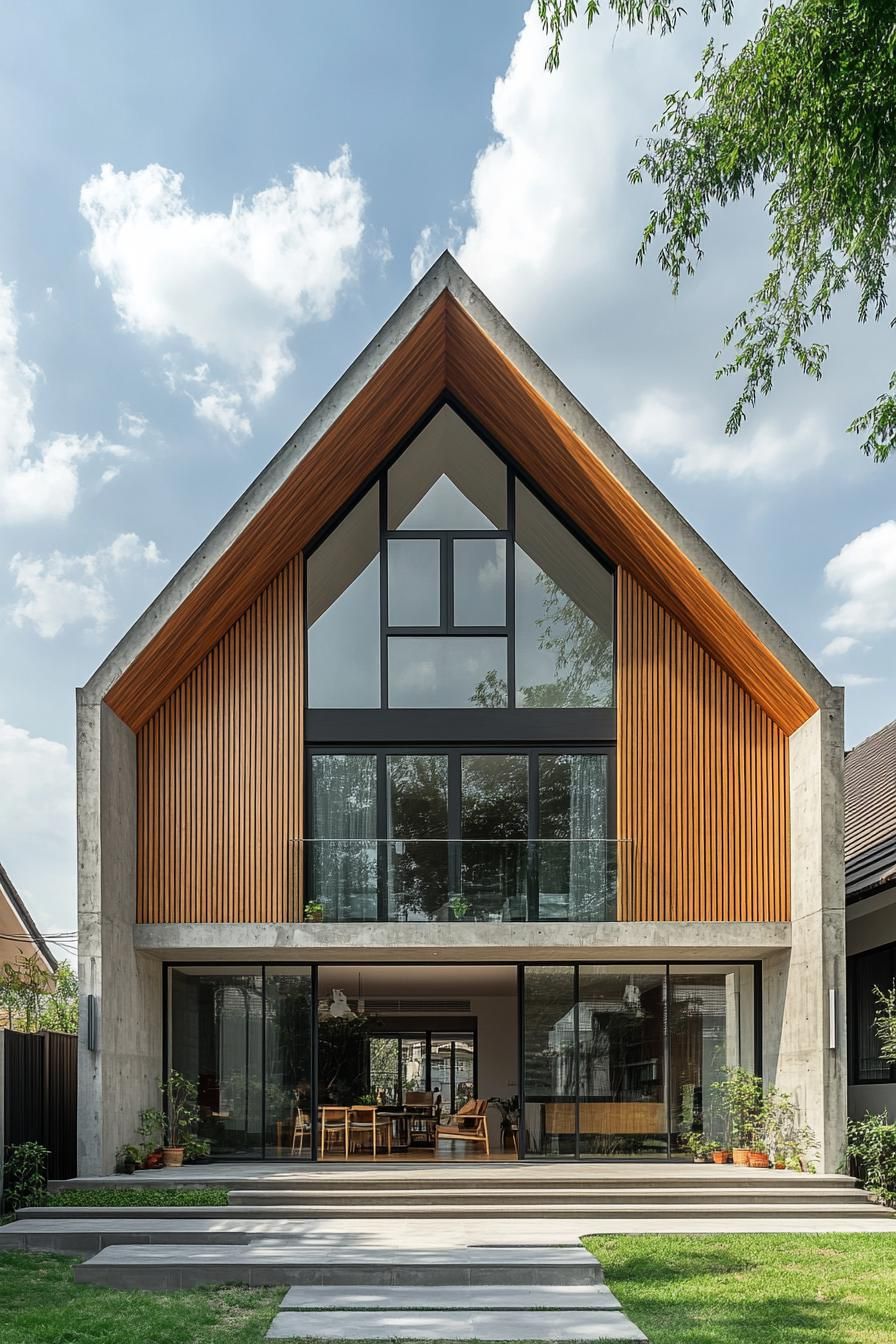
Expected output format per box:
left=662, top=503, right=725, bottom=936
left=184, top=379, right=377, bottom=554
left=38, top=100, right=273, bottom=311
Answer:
left=267, top=1310, right=646, bottom=1344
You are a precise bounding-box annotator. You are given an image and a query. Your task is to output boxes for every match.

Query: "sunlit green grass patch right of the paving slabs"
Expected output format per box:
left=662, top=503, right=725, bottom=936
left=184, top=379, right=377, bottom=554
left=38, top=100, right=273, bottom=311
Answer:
left=583, top=1232, right=896, bottom=1344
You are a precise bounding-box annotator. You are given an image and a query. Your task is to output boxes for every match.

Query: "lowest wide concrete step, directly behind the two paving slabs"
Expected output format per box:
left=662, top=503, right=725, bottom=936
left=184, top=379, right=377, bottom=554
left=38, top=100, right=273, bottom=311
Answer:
left=74, top=1243, right=603, bottom=1290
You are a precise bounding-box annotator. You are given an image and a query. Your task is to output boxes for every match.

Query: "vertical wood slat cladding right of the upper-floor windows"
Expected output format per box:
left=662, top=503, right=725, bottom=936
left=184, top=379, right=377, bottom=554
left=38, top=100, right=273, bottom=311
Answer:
left=617, top=569, right=790, bottom=921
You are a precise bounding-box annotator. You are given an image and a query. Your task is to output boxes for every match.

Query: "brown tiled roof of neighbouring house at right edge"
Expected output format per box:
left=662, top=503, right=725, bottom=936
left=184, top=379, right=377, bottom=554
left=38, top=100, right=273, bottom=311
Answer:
left=845, top=719, right=896, bottom=900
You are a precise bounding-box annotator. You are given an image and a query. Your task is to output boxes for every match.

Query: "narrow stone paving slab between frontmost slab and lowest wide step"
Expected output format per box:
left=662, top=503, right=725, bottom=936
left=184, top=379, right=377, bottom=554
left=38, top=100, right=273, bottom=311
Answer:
left=281, top=1284, right=622, bottom=1312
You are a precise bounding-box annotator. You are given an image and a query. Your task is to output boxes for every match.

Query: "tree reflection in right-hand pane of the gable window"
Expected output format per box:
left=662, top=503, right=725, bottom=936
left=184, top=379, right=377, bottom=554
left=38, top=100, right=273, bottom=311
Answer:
left=517, top=570, right=613, bottom=710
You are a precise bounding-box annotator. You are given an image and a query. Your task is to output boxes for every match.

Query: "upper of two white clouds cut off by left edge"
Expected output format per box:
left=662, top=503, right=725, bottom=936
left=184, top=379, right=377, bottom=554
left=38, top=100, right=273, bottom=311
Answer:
left=0, top=280, right=125, bottom=523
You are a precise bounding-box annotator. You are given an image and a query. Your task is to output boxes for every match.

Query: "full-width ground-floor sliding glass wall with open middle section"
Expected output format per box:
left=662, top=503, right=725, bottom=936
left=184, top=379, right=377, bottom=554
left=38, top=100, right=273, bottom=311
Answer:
left=164, top=962, right=759, bottom=1161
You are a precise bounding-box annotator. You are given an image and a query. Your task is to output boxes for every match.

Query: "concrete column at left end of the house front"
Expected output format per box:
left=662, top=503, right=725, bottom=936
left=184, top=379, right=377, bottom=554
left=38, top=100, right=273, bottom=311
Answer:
left=78, top=691, right=161, bottom=1176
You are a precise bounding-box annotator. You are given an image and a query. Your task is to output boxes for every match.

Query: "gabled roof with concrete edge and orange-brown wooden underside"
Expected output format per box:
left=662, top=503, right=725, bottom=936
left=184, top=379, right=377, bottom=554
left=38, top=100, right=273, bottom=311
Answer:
left=85, top=253, right=832, bottom=732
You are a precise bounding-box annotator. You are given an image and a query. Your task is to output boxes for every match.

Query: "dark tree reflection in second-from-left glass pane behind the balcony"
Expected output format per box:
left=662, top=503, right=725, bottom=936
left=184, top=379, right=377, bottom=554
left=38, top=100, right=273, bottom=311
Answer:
left=388, top=754, right=449, bottom=918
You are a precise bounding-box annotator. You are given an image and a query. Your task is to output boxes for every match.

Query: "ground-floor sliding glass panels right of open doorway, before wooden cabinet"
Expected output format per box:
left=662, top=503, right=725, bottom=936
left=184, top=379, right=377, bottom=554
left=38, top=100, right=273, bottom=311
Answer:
left=520, top=962, right=758, bottom=1159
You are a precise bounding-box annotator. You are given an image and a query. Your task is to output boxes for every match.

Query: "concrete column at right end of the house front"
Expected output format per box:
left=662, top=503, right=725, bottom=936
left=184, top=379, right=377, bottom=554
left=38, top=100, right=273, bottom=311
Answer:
left=763, top=691, right=846, bottom=1172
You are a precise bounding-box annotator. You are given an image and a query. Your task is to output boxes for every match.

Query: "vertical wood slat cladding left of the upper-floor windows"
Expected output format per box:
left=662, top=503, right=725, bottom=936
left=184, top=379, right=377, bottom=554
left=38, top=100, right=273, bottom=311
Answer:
left=137, top=556, right=302, bottom=923
